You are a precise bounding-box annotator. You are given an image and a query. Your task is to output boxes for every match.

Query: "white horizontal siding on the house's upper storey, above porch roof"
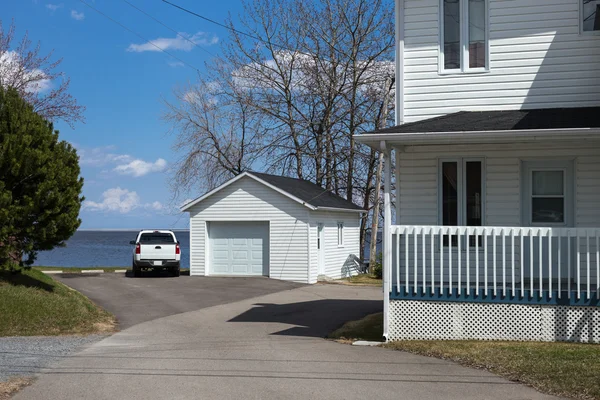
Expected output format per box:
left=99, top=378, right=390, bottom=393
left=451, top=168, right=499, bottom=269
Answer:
left=404, top=0, right=600, bottom=122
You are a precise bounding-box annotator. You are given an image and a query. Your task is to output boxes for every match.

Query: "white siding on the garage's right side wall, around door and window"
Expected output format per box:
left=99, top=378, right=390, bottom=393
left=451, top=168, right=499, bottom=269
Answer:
left=310, top=211, right=360, bottom=279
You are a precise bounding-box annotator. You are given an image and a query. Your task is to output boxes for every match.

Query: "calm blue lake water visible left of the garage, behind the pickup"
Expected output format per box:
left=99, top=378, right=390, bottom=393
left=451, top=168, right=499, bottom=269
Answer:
left=33, top=230, right=190, bottom=268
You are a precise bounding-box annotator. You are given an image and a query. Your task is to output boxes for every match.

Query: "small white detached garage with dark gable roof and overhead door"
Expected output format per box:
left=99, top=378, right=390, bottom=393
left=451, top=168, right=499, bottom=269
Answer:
left=182, top=172, right=364, bottom=283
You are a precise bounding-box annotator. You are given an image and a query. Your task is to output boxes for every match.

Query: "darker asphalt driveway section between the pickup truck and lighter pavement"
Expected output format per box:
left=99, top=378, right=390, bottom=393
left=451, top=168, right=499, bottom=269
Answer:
left=54, top=272, right=302, bottom=329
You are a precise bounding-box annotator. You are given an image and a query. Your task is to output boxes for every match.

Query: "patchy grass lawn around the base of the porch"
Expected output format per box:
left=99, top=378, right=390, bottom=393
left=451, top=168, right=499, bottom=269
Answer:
left=330, top=313, right=600, bottom=400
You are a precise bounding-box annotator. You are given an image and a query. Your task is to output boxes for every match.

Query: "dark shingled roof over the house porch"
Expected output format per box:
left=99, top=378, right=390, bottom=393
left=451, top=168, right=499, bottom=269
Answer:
left=369, top=107, right=600, bottom=133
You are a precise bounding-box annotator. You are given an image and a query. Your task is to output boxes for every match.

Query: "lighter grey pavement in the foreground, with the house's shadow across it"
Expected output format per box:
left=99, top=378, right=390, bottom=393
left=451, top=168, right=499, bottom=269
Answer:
left=15, top=285, right=552, bottom=400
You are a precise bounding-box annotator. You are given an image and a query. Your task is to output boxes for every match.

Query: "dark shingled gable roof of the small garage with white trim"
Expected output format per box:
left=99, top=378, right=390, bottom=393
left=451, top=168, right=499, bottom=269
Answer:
left=181, top=172, right=365, bottom=212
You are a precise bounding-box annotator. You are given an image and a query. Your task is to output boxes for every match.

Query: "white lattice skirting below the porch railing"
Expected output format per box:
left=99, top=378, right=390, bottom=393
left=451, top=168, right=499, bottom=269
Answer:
left=389, top=300, right=600, bottom=343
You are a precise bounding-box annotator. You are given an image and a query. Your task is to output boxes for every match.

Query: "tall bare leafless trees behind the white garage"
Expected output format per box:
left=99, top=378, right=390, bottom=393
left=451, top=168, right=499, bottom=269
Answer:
left=169, top=0, right=394, bottom=257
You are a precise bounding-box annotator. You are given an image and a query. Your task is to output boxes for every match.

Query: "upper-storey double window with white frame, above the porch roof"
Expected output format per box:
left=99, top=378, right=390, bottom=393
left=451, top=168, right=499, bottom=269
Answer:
left=440, top=0, right=488, bottom=72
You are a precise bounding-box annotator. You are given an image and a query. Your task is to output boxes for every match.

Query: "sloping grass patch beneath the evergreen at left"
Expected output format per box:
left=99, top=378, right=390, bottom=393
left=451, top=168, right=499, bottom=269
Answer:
left=0, top=269, right=115, bottom=336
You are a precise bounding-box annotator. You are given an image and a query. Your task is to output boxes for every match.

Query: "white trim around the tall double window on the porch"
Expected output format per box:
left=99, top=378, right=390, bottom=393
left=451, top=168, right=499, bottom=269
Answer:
left=437, top=157, right=486, bottom=226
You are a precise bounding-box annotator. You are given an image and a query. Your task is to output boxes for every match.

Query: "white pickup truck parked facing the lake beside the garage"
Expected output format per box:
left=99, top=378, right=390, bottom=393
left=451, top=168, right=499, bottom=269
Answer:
left=129, top=230, right=181, bottom=277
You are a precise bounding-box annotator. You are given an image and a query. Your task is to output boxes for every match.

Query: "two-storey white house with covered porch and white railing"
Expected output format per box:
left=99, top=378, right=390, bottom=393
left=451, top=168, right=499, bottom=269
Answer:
left=356, top=0, right=600, bottom=342
